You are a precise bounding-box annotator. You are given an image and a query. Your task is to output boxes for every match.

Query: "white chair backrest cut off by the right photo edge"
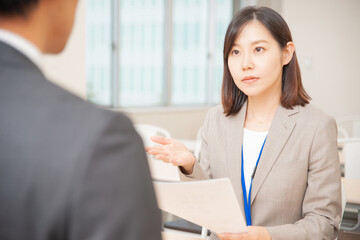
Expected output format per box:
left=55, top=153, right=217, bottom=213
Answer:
left=339, top=138, right=360, bottom=179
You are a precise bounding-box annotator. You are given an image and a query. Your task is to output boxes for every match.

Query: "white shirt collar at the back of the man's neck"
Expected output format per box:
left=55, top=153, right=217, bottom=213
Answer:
left=0, top=28, right=41, bottom=69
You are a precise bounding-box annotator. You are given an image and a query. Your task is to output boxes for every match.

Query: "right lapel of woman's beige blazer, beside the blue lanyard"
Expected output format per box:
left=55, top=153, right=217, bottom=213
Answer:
left=251, top=106, right=299, bottom=203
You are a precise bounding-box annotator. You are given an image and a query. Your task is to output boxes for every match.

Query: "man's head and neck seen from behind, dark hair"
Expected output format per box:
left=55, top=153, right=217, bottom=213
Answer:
left=0, top=0, right=78, bottom=54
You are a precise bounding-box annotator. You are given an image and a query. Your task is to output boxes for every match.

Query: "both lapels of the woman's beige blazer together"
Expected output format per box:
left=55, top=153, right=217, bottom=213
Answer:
left=224, top=102, right=299, bottom=209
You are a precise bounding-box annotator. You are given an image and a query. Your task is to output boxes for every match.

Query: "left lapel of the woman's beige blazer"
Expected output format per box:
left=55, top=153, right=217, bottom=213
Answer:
left=224, top=103, right=247, bottom=216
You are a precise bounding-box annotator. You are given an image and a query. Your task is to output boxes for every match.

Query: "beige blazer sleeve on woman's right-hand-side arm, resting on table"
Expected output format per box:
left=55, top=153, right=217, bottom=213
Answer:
left=267, top=118, right=341, bottom=240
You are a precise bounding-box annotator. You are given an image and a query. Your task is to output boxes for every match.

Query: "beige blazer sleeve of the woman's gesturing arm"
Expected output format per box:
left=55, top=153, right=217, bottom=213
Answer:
left=178, top=108, right=211, bottom=181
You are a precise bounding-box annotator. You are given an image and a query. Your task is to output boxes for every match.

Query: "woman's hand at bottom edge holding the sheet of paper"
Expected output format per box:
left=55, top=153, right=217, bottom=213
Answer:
left=217, top=226, right=271, bottom=240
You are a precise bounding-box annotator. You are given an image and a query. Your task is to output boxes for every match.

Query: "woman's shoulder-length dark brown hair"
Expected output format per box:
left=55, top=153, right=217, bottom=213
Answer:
left=221, top=6, right=311, bottom=116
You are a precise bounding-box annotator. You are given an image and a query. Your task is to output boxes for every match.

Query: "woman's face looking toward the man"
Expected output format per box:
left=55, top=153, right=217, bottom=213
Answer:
left=228, top=20, right=284, bottom=98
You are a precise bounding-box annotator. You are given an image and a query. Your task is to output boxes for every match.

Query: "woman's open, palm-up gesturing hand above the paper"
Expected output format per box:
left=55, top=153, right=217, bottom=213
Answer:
left=145, top=136, right=196, bottom=174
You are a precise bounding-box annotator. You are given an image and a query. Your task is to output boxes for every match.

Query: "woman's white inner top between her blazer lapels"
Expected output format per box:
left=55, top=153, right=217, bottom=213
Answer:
left=243, top=128, right=268, bottom=197
